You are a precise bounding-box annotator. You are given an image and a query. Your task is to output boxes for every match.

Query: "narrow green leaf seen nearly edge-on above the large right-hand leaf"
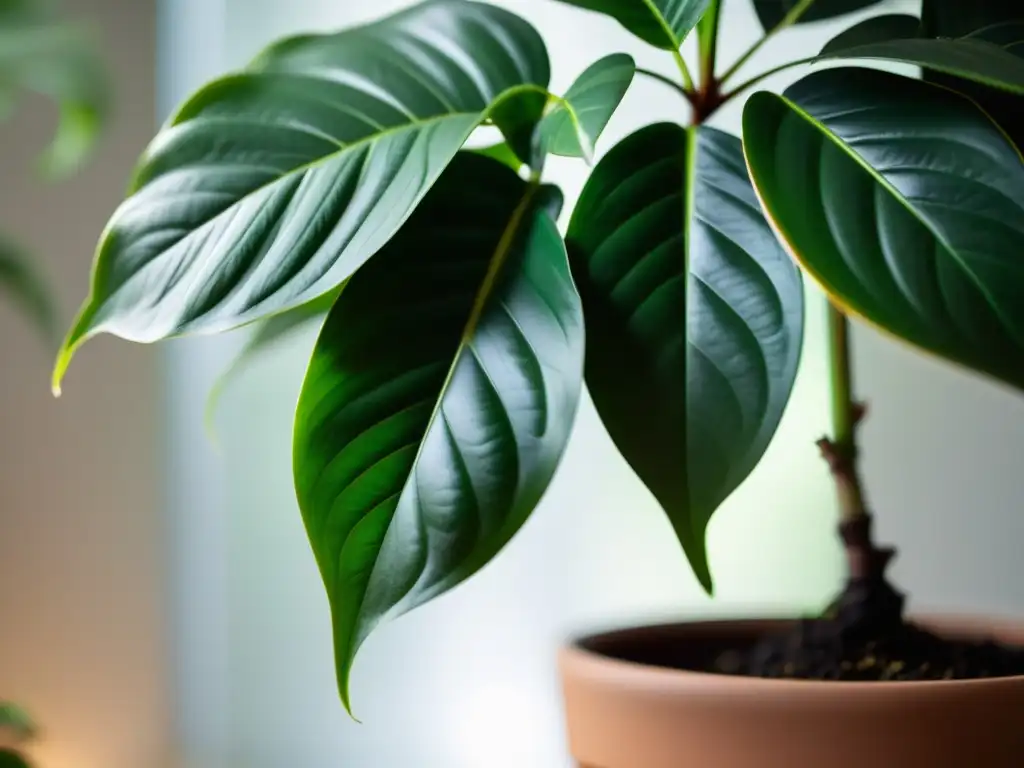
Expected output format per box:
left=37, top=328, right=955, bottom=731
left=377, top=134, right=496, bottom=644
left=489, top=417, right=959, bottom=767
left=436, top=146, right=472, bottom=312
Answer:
left=818, top=14, right=1024, bottom=93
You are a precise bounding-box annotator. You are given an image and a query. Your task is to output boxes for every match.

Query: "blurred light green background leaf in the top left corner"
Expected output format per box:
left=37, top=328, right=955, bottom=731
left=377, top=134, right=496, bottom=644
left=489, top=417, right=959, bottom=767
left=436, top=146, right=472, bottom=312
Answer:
left=0, top=0, right=110, bottom=176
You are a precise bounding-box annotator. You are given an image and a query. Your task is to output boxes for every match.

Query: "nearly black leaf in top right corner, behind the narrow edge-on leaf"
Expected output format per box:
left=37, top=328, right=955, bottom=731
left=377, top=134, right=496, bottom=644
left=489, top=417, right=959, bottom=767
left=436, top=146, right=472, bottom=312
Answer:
left=922, top=0, right=1024, bottom=146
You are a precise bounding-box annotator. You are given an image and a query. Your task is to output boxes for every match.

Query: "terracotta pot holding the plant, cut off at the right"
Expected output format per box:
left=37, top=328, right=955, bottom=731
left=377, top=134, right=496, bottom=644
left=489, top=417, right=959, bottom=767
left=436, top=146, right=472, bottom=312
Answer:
left=560, top=618, right=1024, bottom=768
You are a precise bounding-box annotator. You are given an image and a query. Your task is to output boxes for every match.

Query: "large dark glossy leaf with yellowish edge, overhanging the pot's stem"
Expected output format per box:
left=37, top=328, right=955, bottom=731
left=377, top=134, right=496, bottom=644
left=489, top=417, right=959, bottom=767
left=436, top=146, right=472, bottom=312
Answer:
left=743, top=69, right=1024, bottom=387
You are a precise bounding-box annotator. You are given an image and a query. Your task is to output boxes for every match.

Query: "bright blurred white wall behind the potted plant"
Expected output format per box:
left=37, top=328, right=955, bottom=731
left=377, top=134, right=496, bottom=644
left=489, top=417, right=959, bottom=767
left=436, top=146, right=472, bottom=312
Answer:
left=167, top=0, right=1024, bottom=768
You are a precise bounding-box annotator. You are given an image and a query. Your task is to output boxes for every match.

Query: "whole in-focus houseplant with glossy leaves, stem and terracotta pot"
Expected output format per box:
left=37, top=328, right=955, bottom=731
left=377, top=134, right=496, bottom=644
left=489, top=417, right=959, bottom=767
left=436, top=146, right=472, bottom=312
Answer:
left=54, top=0, right=1024, bottom=768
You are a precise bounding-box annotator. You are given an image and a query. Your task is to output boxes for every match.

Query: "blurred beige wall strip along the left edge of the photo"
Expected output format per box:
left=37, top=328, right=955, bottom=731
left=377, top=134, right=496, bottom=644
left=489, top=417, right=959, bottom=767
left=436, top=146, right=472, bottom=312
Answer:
left=0, top=0, right=169, bottom=768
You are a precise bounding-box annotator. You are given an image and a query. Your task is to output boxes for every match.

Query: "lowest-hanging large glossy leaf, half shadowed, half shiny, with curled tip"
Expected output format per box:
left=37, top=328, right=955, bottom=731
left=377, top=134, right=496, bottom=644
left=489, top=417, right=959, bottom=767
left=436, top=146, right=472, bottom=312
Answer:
left=294, top=153, right=584, bottom=707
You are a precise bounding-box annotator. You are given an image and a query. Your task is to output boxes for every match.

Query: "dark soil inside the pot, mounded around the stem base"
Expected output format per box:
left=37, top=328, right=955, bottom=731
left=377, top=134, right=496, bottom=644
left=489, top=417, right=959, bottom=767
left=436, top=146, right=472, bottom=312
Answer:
left=708, top=580, right=1024, bottom=681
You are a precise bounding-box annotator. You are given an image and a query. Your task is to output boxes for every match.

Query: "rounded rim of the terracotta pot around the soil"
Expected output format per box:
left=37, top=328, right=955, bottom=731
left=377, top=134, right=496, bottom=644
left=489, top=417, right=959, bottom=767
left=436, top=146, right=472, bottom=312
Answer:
left=558, top=613, right=1024, bottom=694
